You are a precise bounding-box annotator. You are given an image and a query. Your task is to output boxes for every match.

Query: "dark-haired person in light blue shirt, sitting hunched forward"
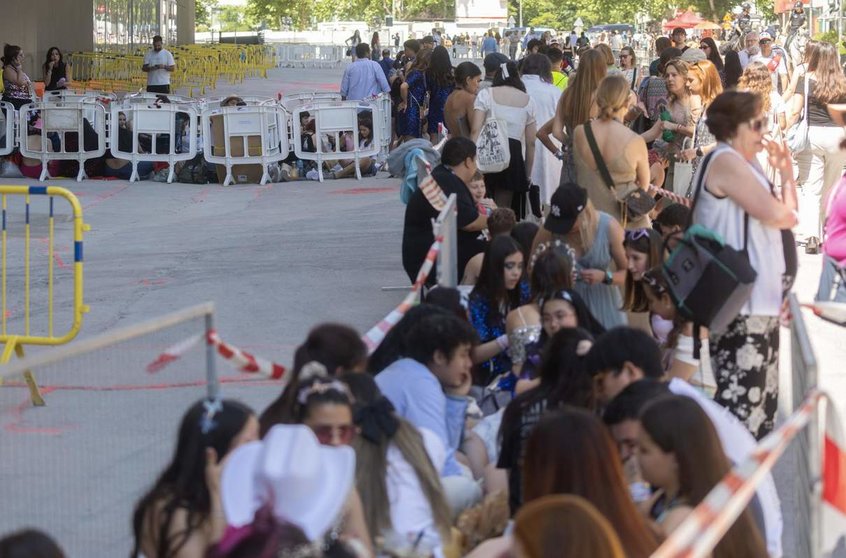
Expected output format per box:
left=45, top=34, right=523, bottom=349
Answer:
left=376, top=309, right=481, bottom=514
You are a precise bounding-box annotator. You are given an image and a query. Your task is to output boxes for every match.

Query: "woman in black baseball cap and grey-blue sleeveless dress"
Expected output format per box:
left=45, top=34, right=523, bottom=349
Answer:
left=529, top=182, right=627, bottom=329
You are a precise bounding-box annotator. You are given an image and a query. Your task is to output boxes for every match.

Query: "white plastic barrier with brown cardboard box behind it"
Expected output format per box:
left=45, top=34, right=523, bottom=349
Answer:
left=202, top=105, right=291, bottom=186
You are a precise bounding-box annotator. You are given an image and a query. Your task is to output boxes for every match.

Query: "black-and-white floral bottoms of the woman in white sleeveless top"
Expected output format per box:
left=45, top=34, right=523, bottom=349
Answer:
left=710, top=315, right=779, bottom=440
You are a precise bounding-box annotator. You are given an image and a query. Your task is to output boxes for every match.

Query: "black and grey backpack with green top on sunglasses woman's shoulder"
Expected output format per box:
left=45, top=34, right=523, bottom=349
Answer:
left=662, top=153, right=758, bottom=333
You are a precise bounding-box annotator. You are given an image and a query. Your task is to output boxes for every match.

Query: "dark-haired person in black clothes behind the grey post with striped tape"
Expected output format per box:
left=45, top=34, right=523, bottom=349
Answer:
left=402, top=137, right=488, bottom=284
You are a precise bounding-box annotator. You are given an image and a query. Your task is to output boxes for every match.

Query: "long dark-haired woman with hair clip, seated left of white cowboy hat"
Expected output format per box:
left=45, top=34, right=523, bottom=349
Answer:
left=131, top=399, right=258, bottom=558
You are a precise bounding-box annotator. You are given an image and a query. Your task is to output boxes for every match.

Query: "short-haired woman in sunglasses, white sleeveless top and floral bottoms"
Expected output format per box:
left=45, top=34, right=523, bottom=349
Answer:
left=693, top=91, right=798, bottom=439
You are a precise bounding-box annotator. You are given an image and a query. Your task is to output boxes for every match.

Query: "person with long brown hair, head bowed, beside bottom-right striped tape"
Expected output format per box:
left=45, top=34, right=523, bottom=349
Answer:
left=637, top=396, right=767, bottom=558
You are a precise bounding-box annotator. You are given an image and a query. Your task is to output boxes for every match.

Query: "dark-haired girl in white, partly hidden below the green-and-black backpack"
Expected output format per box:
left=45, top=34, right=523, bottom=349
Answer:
left=642, top=267, right=717, bottom=397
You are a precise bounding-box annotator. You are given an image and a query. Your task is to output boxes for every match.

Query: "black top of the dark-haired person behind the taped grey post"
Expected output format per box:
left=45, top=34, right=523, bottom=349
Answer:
left=402, top=165, right=485, bottom=284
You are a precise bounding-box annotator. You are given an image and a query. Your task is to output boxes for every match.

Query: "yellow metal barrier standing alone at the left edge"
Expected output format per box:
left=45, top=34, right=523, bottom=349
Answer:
left=0, top=186, right=90, bottom=405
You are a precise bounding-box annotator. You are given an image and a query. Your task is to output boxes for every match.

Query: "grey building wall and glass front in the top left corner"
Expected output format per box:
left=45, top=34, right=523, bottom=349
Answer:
left=0, top=0, right=194, bottom=80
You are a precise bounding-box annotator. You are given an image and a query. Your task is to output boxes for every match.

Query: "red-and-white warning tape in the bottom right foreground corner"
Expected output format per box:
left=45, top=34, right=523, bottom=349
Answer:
left=651, top=390, right=846, bottom=558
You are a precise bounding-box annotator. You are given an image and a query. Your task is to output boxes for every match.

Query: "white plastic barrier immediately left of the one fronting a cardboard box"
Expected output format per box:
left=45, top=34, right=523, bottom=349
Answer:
left=109, top=103, right=199, bottom=184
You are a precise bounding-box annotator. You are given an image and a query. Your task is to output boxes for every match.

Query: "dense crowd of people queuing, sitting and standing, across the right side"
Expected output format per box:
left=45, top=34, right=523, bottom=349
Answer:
left=0, top=16, right=846, bottom=558
